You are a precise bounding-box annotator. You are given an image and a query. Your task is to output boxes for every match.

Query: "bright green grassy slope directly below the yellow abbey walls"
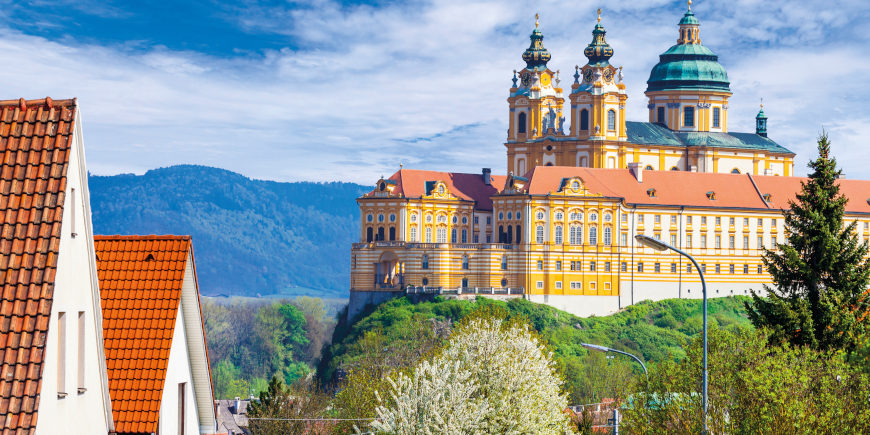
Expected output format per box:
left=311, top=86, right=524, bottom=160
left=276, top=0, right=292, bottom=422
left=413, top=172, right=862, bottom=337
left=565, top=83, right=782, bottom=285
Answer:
left=321, top=296, right=750, bottom=377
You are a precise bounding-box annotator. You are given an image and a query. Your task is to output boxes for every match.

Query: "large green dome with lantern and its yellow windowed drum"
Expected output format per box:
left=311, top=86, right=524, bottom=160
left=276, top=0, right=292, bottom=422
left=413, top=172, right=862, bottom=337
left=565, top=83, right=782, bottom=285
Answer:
left=646, top=0, right=731, bottom=132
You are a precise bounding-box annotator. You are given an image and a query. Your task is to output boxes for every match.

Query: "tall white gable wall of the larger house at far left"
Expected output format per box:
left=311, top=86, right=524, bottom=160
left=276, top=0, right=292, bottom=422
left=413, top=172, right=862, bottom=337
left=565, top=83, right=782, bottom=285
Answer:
left=36, top=109, right=114, bottom=435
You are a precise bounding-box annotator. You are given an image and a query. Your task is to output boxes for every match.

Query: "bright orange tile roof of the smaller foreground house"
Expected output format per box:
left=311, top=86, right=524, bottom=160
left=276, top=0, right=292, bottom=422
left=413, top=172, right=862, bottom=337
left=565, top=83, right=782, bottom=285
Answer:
left=94, top=236, right=192, bottom=433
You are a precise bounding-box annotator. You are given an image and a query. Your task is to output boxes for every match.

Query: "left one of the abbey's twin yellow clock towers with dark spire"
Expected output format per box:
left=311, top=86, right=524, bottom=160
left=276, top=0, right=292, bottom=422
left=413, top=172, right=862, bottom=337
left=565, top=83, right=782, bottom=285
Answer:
left=505, top=14, right=565, bottom=174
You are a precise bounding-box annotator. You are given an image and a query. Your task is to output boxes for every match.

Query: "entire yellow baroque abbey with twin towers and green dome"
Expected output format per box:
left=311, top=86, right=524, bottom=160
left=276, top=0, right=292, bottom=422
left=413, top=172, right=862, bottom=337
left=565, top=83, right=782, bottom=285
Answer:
left=349, top=5, right=870, bottom=316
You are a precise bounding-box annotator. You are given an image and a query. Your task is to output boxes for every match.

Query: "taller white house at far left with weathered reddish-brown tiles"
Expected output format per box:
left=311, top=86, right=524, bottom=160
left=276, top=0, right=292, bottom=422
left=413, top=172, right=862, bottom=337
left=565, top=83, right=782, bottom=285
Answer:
left=0, top=98, right=114, bottom=435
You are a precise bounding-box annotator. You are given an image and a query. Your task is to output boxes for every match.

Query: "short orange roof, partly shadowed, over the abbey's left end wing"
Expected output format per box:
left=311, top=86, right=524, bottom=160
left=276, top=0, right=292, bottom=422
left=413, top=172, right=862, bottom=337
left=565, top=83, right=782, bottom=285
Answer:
left=370, top=169, right=507, bottom=210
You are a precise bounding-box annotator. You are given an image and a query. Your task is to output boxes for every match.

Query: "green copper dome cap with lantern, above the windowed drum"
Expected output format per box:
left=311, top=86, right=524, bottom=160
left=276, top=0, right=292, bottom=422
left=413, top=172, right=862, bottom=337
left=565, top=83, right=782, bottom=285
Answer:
left=646, top=10, right=731, bottom=92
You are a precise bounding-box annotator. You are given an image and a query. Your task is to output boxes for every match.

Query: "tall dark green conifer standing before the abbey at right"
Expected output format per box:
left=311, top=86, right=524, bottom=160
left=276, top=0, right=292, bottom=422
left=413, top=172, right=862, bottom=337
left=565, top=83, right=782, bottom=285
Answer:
left=746, top=133, right=870, bottom=351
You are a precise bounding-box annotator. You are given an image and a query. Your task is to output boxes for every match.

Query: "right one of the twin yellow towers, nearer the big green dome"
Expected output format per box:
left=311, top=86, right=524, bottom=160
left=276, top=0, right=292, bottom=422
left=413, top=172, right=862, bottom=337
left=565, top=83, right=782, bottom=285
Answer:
left=571, top=9, right=628, bottom=149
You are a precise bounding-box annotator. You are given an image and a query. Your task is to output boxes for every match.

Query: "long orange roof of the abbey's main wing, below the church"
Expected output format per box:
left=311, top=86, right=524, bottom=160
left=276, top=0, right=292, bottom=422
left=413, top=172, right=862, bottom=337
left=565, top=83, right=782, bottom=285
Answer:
left=525, top=166, right=870, bottom=213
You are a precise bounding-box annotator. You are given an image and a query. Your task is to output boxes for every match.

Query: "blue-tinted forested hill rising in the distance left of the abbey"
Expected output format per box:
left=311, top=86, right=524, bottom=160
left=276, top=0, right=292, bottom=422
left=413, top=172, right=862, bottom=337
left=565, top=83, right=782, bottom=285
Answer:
left=89, top=165, right=369, bottom=297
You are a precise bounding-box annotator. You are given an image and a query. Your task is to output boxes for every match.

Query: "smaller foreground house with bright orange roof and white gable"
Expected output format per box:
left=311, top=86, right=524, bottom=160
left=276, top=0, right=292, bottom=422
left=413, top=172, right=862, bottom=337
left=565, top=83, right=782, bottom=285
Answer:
left=94, top=236, right=217, bottom=435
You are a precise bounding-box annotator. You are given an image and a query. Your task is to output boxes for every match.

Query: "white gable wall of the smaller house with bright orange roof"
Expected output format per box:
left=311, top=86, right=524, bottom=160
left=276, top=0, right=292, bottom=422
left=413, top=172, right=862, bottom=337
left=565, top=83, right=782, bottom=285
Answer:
left=159, top=304, right=199, bottom=435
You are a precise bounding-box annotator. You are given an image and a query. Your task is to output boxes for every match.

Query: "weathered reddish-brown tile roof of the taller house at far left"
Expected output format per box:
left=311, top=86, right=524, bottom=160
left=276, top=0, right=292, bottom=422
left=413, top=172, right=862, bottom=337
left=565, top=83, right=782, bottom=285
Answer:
left=0, top=98, right=76, bottom=434
